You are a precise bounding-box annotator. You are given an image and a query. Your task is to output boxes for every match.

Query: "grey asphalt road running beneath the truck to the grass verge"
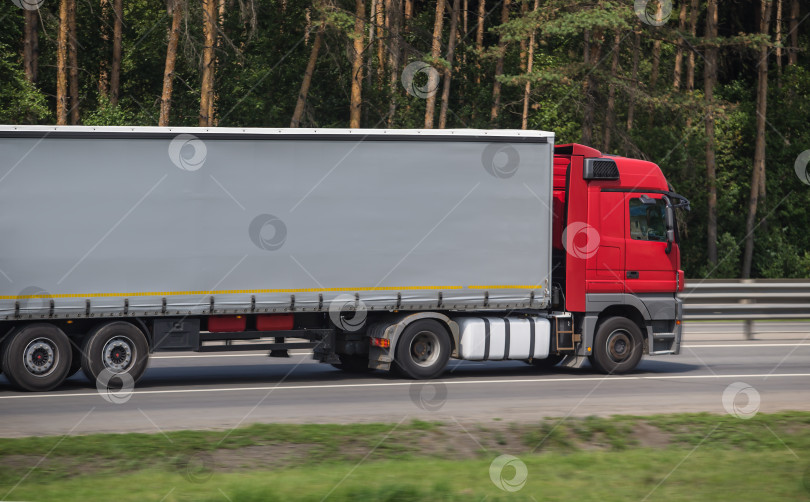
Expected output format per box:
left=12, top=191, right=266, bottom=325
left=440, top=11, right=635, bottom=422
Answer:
left=0, top=323, right=810, bottom=437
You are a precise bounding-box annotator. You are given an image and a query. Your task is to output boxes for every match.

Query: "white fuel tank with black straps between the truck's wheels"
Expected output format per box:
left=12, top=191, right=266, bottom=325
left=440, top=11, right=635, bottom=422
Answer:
left=455, top=317, right=551, bottom=361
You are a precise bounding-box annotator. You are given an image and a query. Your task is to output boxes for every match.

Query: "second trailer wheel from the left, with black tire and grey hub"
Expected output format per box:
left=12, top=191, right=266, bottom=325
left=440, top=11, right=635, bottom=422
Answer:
left=82, top=321, right=149, bottom=383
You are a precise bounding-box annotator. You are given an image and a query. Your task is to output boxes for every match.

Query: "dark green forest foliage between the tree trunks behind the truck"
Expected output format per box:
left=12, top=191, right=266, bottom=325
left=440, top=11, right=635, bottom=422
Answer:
left=0, top=0, right=810, bottom=278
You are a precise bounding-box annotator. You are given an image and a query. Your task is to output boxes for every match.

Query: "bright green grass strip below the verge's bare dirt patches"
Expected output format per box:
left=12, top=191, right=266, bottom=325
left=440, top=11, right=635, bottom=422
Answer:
left=3, top=448, right=810, bottom=502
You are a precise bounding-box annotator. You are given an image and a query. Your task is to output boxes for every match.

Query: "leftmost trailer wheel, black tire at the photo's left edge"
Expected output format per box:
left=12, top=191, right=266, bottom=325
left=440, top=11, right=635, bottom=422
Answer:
left=0, top=323, right=73, bottom=392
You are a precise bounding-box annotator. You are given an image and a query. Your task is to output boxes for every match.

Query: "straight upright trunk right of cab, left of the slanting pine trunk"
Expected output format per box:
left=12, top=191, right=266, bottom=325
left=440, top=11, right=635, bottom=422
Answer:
left=703, top=0, right=718, bottom=265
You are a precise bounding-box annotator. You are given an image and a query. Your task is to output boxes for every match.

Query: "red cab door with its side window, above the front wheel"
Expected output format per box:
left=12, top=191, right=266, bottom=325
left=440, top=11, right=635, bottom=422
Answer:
left=624, top=192, right=678, bottom=293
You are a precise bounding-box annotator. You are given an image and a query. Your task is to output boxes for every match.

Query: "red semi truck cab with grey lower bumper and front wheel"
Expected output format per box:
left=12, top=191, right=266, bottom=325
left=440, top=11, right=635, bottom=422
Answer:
left=552, top=144, right=689, bottom=372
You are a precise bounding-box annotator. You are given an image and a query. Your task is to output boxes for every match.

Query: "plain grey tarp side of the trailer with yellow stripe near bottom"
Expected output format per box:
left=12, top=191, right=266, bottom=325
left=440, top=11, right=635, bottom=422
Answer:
left=0, top=127, right=553, bottom=319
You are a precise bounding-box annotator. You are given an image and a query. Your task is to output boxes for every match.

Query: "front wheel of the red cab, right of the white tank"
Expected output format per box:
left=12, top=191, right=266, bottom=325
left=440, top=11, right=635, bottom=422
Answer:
left=590, top=317, right=644, bottom=374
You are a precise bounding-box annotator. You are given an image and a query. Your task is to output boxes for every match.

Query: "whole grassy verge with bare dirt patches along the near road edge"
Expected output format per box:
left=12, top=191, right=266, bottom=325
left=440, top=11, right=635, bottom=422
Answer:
left=0, top=412, right=810, bottom=502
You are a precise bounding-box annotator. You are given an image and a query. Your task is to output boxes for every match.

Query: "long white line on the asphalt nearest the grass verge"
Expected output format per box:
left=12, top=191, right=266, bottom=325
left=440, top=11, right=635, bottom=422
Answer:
left=0, top=373, right=810, bottom=399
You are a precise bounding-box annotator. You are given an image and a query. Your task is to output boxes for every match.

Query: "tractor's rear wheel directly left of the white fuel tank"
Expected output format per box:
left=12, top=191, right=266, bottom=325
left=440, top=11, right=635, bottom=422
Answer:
left=394, top=319, right=450, bottom=380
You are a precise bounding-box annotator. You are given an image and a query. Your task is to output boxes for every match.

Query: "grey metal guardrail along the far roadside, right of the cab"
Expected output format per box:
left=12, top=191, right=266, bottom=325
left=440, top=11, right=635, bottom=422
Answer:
left=679, top=279, right=810, bottom=339
